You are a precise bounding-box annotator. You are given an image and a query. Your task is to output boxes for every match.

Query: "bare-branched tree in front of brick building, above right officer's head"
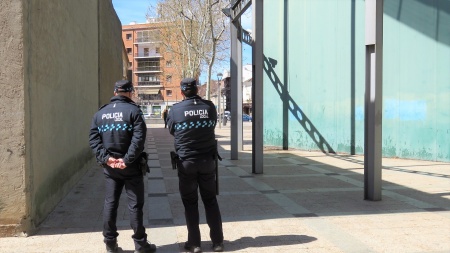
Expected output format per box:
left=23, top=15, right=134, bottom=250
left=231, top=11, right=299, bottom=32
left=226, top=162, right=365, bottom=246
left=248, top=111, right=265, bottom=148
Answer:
left=149, top=0, right=229, bottom=99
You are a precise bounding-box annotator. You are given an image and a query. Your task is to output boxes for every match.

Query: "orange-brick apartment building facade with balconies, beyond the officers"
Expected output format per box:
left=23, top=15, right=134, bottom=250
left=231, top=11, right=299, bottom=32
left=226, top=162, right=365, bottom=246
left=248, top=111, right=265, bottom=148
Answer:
left=122, top=19, right=183, bottom=118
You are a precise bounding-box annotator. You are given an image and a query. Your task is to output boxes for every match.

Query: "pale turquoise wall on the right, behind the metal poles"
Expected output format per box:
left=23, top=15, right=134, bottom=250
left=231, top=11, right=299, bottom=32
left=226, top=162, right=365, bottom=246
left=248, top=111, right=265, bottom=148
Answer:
left=263, top=0, right=450, bottom=161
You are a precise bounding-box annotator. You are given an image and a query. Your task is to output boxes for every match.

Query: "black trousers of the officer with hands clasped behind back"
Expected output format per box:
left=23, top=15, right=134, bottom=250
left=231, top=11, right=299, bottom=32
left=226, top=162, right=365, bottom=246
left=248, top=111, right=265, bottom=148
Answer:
left=103, top=169, right=147, bottom=249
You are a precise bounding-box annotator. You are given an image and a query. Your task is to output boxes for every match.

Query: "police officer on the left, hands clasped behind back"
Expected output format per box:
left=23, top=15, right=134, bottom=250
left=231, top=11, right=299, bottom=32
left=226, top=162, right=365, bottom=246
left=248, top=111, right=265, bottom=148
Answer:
left=89, top=80, right=156, bottom=253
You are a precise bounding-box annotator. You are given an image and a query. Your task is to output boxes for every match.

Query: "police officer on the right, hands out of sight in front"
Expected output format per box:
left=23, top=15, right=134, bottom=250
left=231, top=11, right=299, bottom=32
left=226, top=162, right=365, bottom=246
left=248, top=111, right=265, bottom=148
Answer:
left=167, top=78, right=223, bottom=252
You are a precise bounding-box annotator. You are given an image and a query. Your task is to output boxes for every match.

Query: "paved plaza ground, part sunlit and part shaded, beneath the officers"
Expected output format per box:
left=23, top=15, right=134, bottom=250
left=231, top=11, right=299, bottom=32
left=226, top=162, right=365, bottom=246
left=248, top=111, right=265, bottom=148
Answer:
left=0, top=122, right=450, bottom=253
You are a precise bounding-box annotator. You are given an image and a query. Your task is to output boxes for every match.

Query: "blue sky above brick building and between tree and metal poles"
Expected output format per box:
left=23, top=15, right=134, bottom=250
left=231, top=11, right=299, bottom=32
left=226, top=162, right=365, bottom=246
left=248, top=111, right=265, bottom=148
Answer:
left=112, top=0, right=252, bottom=83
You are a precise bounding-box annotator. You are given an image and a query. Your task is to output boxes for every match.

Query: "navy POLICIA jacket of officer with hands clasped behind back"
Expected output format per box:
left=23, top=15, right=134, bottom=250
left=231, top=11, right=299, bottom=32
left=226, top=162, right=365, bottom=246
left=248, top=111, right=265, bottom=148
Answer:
left=89, top=96, right=147, bottom=167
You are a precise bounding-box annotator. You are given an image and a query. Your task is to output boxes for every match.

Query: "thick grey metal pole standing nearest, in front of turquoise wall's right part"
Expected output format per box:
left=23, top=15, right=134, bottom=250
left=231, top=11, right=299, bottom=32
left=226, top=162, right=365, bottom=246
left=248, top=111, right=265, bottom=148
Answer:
left=364, top=0, right=383, bottom=200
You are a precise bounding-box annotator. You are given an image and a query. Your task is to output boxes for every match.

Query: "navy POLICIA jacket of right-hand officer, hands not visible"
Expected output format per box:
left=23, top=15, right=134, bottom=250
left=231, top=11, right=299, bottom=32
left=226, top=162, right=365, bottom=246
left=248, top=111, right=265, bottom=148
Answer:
left=167, top=96, right=217, bottom=160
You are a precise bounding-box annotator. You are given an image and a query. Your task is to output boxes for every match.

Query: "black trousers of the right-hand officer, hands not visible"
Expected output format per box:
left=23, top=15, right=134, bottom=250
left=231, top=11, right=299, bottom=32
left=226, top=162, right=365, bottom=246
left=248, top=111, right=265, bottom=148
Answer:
left=178, top=157, right=223, bottom=246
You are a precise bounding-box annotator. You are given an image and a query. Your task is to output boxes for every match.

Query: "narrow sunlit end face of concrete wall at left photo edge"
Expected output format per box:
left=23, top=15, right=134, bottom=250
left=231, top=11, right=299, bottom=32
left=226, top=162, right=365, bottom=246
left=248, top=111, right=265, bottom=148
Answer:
left=0, top=1, right=28, bottom=236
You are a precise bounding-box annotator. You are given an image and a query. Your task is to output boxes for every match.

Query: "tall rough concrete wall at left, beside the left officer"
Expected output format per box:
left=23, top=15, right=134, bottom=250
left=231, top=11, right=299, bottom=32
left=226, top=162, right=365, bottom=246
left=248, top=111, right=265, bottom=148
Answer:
left=0, top=0, right=122, bottom=235
